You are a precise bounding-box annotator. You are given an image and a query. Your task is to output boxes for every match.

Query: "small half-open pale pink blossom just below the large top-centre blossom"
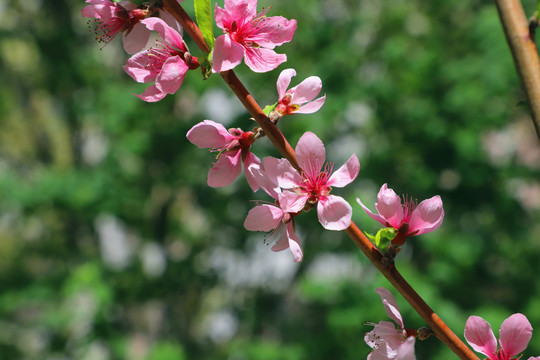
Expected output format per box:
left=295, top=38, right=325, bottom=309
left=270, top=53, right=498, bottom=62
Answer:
left=276, top=69, right=326, bottom=117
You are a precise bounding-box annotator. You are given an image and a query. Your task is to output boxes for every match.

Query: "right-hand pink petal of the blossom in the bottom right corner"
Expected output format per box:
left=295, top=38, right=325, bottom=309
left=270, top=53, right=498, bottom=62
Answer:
left=499, top=313, right=532, bottom=358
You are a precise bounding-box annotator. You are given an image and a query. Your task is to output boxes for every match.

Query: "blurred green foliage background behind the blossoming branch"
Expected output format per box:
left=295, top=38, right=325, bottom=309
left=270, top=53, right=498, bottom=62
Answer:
left=0, top=0, right=540, bottom=360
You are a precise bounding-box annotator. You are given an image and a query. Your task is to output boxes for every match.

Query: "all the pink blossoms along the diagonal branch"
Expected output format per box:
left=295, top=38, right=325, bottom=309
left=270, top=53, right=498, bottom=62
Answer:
left=82, top=0, right=540, bottom=360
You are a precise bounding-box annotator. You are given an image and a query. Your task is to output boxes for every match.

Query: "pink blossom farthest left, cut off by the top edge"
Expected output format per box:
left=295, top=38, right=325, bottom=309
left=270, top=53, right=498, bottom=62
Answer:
left=81, top=0, right=150, bottom=54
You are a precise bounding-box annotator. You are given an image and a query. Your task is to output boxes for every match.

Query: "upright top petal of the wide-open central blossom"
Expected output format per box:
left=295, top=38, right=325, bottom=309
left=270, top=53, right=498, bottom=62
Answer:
left=296, top=131, right=326, bottom=176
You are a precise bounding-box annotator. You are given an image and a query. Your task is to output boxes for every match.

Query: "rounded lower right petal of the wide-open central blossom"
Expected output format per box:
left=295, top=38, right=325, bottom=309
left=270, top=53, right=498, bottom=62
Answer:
left=317, top=195, right=352, bottom=231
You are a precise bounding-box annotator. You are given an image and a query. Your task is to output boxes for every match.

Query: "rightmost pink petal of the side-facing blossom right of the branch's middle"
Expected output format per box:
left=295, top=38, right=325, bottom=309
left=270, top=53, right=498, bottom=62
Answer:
left=410, top=195, right=444, bottom=235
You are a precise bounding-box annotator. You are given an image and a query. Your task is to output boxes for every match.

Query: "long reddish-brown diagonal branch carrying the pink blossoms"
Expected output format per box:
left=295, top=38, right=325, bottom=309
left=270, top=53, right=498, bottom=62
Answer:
left=163, top=0, right=479, bottom=360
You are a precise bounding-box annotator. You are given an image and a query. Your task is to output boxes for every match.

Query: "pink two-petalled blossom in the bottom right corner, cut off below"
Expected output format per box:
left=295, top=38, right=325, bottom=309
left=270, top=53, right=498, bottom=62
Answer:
left=465, top=313, right=540, bottom=360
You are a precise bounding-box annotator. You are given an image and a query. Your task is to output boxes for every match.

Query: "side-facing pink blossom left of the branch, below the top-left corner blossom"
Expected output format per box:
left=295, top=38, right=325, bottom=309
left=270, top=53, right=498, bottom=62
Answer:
left=124, top=17, right=199, bottom=102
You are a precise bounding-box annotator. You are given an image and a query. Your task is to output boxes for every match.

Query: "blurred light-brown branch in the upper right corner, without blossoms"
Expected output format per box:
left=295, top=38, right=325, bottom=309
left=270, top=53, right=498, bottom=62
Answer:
left=495, top=0, right=540, bottom=140
